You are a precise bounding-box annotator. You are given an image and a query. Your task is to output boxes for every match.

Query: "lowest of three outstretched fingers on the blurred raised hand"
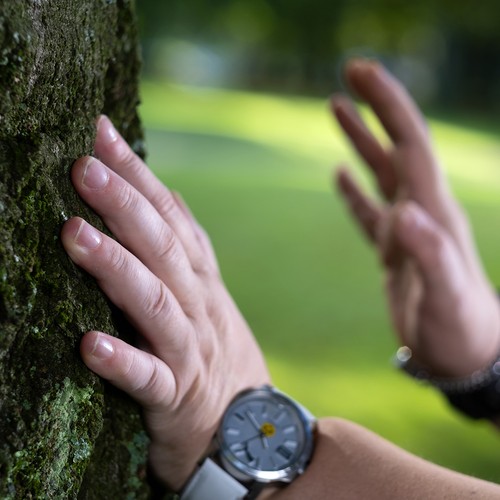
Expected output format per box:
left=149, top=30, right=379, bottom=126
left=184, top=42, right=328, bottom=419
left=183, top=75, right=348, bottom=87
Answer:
left=336, top=169, right=382, bottom=242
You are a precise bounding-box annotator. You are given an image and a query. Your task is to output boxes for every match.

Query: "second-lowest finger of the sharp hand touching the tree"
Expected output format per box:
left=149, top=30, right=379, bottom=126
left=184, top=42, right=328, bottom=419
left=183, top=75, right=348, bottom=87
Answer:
left=61, top=217, right=192, bottom=366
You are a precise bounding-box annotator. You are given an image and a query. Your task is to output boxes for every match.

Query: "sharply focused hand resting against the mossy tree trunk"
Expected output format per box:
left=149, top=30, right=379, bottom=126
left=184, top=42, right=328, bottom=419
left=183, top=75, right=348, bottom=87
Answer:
left=62, top=117, right=269, bottom=489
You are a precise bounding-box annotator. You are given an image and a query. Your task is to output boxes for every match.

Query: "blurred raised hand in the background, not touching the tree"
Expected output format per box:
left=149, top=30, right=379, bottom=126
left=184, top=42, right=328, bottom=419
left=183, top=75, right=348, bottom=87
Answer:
left=331, top=60, right=500, bottom=377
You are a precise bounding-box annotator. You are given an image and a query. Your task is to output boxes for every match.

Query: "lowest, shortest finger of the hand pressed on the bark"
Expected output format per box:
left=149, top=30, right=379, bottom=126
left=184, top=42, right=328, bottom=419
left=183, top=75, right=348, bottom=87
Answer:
left=80, top=332, right=176, bottom=409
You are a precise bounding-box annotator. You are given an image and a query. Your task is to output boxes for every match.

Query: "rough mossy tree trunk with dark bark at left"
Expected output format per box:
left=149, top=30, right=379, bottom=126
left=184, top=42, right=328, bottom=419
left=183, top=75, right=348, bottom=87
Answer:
left=0, top=0, right=149, bottom=499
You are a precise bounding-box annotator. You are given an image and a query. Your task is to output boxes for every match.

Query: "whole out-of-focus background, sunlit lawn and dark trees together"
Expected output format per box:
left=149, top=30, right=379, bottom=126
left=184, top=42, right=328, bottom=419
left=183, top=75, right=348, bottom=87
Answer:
left=137, top=0, right=500, bottom=482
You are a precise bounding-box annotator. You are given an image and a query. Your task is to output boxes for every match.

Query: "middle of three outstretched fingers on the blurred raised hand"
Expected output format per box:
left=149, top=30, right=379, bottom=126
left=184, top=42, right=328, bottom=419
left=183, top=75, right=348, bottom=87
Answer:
left=331, top=95, right=398, bottom=200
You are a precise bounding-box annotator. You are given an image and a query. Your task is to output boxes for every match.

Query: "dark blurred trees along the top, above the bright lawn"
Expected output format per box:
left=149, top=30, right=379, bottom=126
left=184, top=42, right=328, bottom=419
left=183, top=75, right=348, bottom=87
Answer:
left=138, top=0, right=500, bottom=109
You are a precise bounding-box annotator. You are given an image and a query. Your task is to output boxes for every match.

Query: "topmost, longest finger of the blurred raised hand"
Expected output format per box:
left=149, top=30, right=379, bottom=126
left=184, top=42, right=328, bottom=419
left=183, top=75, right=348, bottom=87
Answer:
left=346, top=60, right=428, bottom=146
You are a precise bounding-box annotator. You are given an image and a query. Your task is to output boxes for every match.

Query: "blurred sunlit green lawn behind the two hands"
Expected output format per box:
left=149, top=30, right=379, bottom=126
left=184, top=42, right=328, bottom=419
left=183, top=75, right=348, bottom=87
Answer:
left=141, top=82, right=500, bottom=482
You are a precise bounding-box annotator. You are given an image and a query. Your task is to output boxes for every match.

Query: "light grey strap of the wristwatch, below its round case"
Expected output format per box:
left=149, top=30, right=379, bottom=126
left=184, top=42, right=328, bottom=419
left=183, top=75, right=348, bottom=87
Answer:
left=180, top=458, right=248, bottom=500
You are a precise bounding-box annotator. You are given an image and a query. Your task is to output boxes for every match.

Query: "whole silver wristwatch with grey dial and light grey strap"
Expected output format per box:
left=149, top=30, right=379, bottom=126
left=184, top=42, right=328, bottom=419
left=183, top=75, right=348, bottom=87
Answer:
left=180, top=385, right=315, bottom=500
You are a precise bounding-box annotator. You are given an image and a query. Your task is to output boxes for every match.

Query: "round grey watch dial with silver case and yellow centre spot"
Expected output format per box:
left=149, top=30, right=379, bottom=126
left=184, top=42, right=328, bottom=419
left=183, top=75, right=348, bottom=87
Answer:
left=218, top=389, right=312, bottom=481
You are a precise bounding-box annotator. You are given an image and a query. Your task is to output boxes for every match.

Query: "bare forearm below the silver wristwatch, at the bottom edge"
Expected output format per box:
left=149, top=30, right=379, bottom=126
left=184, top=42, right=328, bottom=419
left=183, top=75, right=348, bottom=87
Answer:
left=259, top=419, right=500, bottom=500
